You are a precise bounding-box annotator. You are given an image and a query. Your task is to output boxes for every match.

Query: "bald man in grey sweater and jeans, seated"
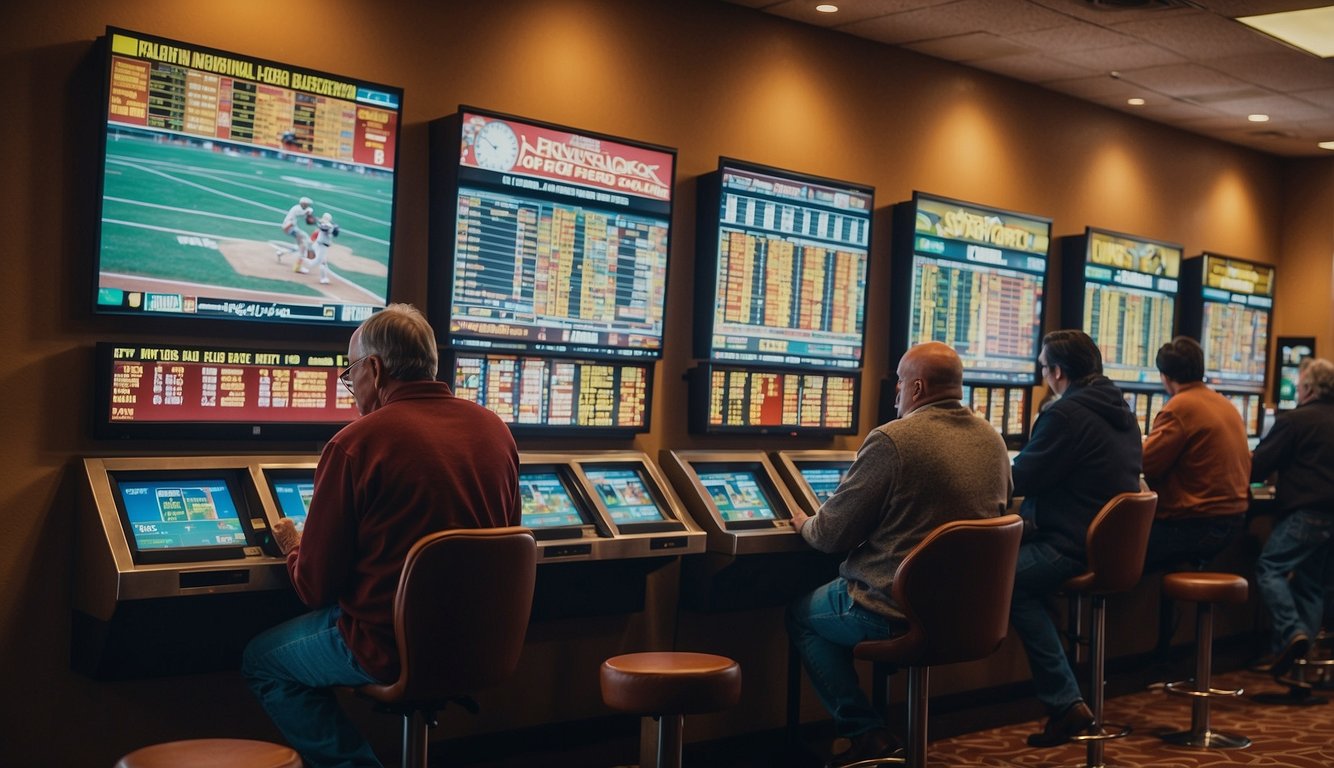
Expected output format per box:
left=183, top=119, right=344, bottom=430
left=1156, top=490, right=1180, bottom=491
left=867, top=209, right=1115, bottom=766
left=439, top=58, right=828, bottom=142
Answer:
left=787, top=341, right=1010, bottom=765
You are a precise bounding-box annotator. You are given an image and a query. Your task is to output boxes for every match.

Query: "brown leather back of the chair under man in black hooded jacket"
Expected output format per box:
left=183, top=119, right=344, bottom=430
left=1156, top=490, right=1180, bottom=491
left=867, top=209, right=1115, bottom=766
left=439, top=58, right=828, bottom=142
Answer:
left=1065, top=491, right=1158, bottom=595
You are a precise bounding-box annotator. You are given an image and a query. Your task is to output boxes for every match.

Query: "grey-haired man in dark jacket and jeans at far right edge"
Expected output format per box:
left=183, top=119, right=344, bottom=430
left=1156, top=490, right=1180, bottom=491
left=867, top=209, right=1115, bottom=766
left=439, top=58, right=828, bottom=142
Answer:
left=1251, top=359, right=1334, bottom=677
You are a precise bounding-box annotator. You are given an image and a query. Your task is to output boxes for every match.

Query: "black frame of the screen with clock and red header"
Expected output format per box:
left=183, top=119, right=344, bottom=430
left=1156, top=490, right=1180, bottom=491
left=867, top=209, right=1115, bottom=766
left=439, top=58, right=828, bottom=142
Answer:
left=427, top=104, right=680, bottom=364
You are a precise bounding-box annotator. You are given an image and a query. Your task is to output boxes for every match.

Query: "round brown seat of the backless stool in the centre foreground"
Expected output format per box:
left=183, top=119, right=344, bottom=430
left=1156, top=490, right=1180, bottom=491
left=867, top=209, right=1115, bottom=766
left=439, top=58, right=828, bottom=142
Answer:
left=602, top=652, right=742, bottom=715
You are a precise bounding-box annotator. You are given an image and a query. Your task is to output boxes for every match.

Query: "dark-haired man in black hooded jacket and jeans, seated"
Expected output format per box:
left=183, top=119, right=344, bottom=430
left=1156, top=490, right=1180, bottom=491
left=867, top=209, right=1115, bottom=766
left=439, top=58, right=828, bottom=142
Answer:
left=1010, top=331, right=1142, bottom=747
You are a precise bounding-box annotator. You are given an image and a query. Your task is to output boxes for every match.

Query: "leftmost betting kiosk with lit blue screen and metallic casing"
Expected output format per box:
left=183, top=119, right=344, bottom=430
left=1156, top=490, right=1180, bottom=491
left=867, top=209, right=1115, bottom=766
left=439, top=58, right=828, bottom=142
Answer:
left=71, top=456, right=306, bottom=677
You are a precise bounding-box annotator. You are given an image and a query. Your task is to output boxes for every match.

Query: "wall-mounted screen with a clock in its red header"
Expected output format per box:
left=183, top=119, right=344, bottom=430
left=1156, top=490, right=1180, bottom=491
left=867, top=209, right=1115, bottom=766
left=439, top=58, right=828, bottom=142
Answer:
left=430, top=107, right=676, bottom=357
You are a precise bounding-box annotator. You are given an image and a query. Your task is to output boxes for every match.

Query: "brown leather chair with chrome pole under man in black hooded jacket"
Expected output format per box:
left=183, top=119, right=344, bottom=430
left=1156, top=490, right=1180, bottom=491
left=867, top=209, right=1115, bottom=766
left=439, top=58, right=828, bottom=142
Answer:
left=1063, top=491, right=1158, bottom=768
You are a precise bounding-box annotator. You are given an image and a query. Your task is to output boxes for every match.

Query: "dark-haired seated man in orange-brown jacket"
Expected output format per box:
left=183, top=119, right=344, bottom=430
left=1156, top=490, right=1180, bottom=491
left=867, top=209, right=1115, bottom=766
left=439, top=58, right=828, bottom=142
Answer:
left=1143, top=336, right=1250, bottom=571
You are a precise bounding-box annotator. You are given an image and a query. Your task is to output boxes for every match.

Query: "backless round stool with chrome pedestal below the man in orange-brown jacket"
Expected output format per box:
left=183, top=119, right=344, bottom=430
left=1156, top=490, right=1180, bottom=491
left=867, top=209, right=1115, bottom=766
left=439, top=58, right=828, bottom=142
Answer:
left=1162, top=571, right=1250, bottom=749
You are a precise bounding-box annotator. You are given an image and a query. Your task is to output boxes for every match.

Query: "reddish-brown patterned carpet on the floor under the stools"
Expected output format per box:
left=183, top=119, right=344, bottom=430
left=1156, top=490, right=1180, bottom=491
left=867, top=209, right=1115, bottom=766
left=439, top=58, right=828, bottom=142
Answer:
left=930, top=672, right=1334, bottom=768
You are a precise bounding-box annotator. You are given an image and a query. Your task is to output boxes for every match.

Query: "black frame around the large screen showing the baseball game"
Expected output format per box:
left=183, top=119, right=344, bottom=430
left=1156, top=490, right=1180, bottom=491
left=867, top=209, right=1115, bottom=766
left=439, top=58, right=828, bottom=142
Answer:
left=88, top=25, right=404, bottom=332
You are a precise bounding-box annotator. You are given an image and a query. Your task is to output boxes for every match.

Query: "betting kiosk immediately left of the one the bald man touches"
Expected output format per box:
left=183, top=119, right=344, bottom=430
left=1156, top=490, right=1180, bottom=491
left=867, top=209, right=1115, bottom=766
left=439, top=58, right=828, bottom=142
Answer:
left=660, top=451, right=838, bottom=611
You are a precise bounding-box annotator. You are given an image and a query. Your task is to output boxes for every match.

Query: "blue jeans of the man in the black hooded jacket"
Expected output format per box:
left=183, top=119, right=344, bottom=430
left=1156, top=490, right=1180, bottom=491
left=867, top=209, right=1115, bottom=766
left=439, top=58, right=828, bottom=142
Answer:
left=1010, top=541, right=1085, bottom=713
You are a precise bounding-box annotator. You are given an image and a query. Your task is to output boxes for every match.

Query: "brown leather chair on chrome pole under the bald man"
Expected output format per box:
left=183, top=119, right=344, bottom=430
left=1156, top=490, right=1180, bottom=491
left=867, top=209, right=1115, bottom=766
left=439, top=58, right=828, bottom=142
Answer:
left=852, top=515, right=1023, bottom=768
